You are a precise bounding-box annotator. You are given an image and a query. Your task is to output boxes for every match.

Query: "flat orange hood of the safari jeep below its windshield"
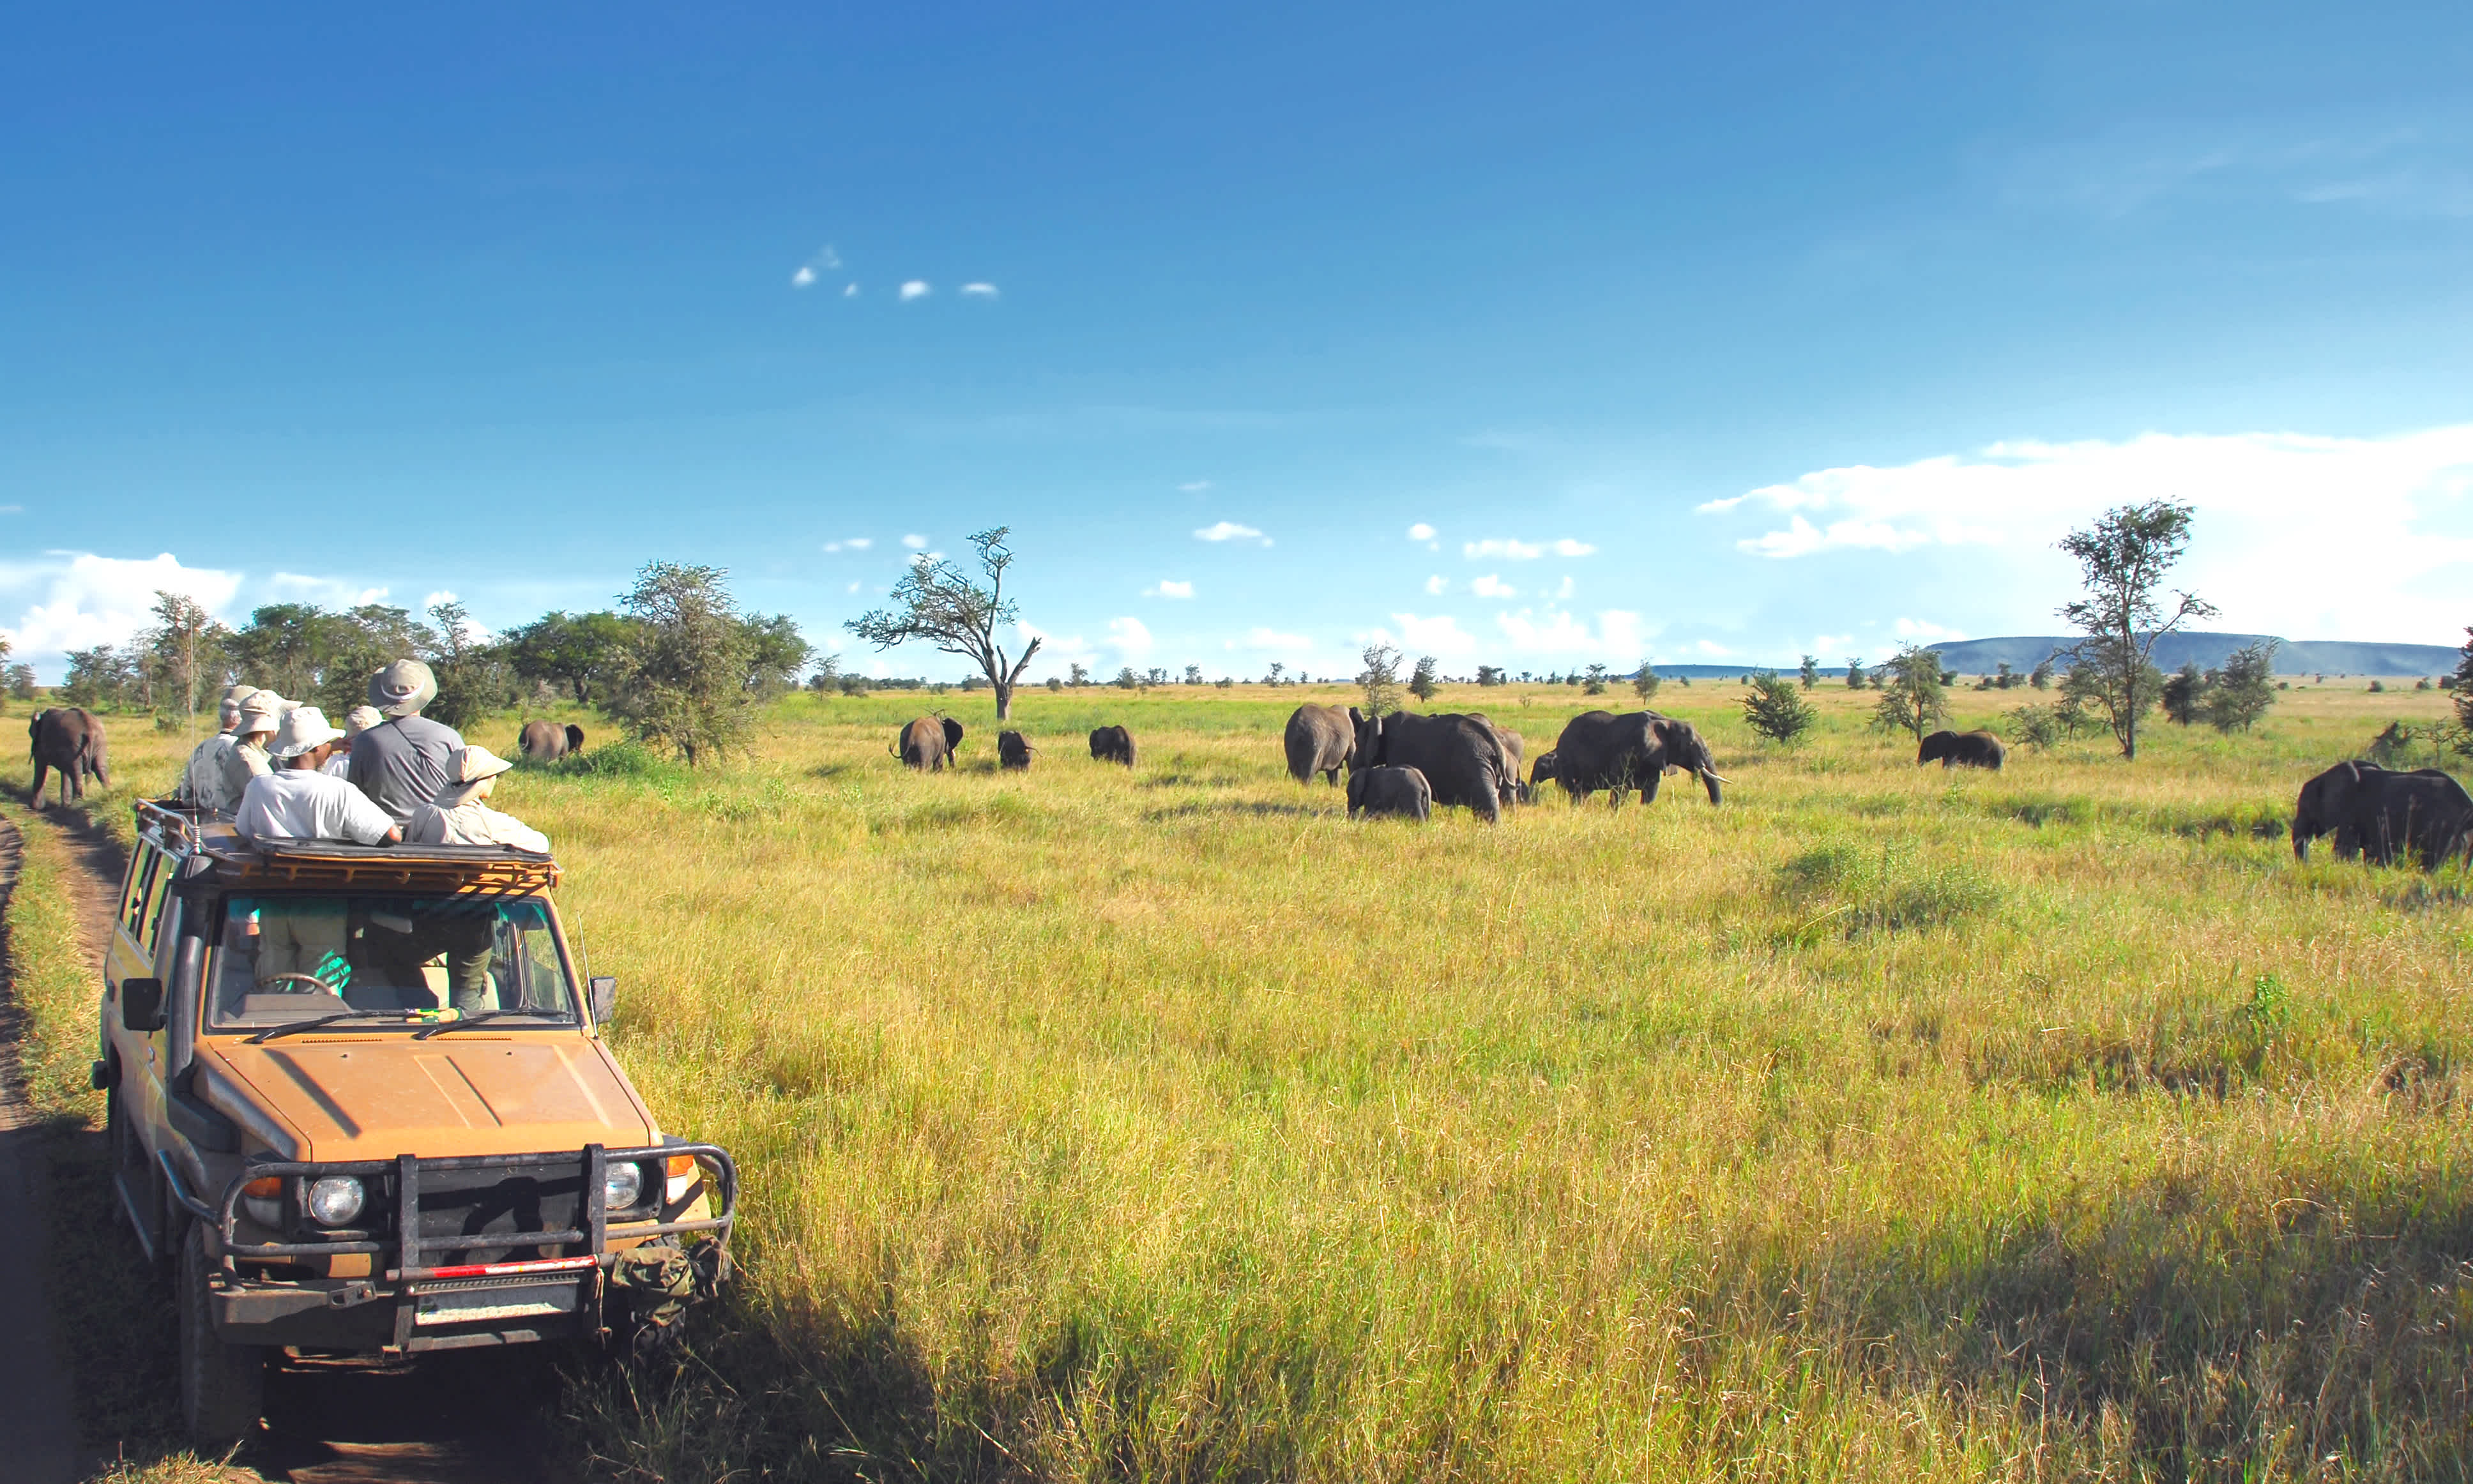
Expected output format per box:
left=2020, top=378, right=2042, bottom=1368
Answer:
left=198, top=1034, right=658, bottom=1160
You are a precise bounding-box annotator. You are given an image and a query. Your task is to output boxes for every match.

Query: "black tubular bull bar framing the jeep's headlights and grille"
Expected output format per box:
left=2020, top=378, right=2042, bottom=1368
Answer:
left=158, top=1142, right=740, bottom=1283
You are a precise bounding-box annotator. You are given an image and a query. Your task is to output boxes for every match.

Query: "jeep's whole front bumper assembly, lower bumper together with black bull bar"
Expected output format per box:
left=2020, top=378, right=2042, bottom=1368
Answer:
left=161, top=1142, right=740, bottom=1353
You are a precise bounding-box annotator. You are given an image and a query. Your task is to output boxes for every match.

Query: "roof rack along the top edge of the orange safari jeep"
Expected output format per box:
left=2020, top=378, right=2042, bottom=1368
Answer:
left=131, top=799, right=564, bottom=895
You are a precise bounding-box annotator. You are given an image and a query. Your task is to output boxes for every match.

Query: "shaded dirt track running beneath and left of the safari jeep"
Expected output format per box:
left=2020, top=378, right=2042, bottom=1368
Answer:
left=0, top=819, right=559, bottom=1484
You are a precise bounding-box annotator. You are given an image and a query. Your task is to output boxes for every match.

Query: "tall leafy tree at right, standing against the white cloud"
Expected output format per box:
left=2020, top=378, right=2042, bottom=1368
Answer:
left=2060, top=499, right=2216, bottom=762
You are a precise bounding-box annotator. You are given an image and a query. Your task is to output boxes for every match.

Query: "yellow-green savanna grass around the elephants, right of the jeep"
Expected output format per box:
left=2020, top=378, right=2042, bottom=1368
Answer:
left=19, top=685, right=2473, bottom=1481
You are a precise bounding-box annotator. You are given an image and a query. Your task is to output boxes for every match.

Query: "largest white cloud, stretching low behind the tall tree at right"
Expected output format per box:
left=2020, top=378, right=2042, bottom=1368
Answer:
left=1701, top=423, right=2473, bottom=643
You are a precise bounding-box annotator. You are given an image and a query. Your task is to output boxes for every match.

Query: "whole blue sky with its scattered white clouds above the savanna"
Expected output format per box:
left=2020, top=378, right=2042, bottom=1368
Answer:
left=0, top=3, right=2473, bottom=675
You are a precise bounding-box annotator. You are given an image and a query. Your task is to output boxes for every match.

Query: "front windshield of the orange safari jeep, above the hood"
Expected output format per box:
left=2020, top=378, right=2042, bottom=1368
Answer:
left=205, top=893, right=576, bottom=1031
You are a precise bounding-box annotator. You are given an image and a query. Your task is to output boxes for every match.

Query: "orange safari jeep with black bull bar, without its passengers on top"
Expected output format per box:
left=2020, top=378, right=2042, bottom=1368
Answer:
left=94, top=804, right=737, bottom=1447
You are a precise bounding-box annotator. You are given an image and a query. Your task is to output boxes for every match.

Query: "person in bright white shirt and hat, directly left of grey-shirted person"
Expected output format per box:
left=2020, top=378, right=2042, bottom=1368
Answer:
left=232, top=705, right=403, bottom=994
